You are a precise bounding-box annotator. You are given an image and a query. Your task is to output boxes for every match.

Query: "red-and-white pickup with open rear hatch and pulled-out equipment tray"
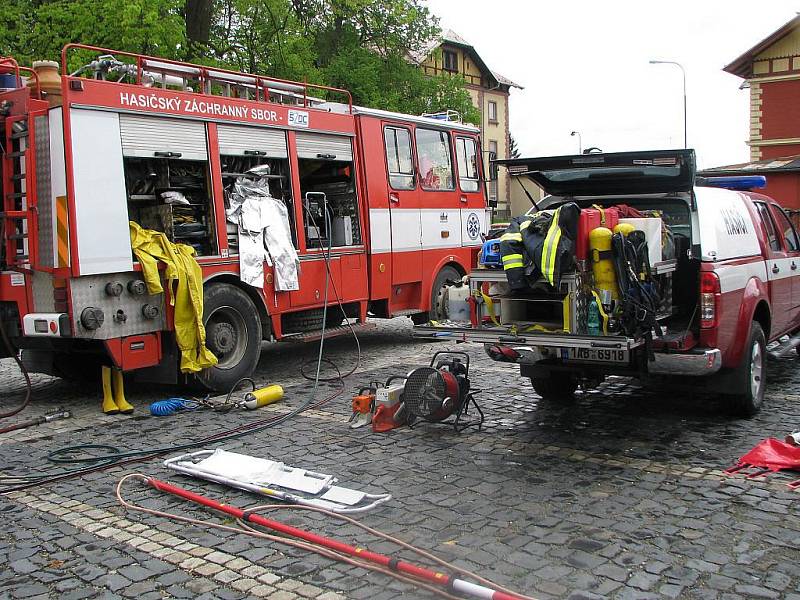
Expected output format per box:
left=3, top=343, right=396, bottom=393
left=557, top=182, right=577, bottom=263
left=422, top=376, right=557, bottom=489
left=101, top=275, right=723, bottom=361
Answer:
left=415, top=150, right=800, bottom=416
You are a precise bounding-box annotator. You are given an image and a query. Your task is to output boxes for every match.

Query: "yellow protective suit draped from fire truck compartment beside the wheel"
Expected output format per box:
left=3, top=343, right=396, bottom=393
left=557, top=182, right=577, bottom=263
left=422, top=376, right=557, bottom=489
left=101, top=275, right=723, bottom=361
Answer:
left=130, top=221, right=217, bottom=373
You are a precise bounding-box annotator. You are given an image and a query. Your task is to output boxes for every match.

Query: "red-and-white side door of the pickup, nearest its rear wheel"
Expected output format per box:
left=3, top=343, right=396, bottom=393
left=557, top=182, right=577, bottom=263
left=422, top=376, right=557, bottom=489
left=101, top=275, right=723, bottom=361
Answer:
left=754, top=202, right=797, bottom=339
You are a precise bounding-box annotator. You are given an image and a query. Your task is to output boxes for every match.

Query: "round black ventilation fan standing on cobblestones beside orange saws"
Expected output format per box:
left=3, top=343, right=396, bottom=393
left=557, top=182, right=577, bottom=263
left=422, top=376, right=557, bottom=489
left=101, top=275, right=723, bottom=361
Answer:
left=403, top=352, right=483, bottom=431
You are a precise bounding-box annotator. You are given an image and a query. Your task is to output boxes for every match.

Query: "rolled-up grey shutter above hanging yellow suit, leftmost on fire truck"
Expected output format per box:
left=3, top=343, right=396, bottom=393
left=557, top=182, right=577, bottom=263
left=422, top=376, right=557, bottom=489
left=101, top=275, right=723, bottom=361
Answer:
left=119, top=114, right=208, bottom=160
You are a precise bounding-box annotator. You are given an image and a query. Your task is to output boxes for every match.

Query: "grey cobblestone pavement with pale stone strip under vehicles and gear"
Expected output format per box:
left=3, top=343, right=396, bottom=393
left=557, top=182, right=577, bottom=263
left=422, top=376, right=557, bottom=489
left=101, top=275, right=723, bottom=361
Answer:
left=0, top=319, right=800, bottom=600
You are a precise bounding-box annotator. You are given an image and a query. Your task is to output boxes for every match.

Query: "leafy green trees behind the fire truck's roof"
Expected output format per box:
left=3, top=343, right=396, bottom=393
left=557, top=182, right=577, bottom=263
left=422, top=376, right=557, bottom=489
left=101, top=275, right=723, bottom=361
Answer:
left=0, top=0, right=480, bottom=123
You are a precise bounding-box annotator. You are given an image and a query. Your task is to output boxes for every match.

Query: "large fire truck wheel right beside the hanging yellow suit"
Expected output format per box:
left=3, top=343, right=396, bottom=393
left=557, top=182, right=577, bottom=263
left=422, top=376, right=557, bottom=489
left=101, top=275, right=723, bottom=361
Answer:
left=197, top=283, right=261, bottom=391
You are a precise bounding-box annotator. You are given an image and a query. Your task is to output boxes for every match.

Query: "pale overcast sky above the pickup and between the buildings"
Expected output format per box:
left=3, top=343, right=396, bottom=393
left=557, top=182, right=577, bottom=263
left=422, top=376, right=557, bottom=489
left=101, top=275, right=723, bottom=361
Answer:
left=427, top=0, right=800, bottom=168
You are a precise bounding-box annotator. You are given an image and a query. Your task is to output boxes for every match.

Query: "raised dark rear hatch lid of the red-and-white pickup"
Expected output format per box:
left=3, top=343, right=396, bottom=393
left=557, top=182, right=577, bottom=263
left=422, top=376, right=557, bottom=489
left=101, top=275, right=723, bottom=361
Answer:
left=494, top=149, right=696, bottom=197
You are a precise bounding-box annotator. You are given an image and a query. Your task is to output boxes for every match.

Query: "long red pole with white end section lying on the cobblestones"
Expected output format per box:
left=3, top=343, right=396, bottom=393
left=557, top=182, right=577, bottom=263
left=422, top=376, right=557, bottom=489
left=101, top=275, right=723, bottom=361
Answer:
left=147, top=477, right=523, bottom=600
